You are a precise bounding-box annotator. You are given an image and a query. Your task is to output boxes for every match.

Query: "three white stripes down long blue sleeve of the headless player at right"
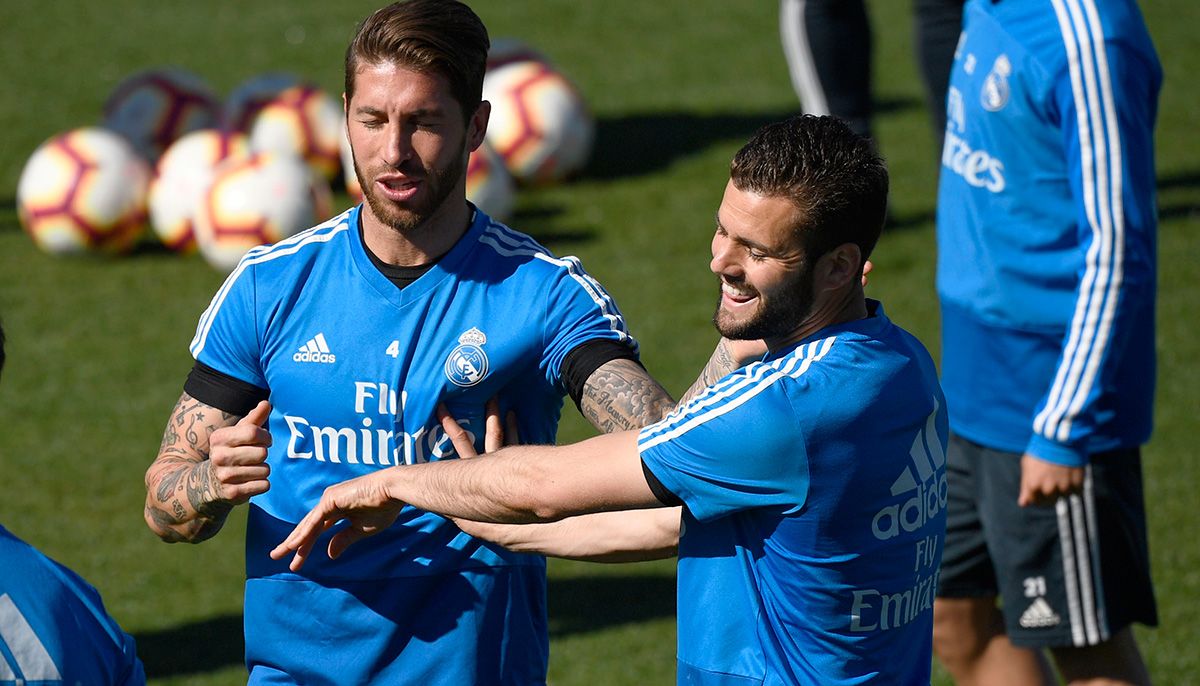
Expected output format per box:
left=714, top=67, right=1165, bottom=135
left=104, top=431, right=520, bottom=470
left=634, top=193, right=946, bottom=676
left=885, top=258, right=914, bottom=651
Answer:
left=1033, top=0, right=1124, bottom=441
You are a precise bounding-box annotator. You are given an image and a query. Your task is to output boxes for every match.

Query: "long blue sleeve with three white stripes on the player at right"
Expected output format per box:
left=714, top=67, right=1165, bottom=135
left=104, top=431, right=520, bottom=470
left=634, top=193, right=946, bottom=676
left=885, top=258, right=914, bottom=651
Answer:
left=1026, top=29, right=1162, bottom=467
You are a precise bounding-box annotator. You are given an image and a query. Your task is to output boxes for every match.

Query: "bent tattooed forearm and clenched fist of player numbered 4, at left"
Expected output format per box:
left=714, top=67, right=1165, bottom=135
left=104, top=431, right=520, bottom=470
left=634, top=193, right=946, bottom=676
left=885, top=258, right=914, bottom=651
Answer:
left=144, top=393, right=271, bottom=543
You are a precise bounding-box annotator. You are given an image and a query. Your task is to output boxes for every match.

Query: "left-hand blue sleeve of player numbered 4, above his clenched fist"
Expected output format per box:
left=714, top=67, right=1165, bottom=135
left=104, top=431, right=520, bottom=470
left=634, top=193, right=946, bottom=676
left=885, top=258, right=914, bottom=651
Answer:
left=191, top=258, right=268, bottom=389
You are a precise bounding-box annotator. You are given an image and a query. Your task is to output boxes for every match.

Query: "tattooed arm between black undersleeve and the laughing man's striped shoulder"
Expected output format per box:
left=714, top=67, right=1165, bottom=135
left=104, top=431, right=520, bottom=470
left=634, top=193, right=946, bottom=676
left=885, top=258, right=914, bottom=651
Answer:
left=580, top=360, right=674, bottom=433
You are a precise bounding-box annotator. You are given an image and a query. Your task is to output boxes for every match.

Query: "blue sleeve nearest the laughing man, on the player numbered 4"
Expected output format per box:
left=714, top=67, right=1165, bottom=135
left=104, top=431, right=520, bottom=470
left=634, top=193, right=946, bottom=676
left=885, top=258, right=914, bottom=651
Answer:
left=541, top=255, right=637, bottom=389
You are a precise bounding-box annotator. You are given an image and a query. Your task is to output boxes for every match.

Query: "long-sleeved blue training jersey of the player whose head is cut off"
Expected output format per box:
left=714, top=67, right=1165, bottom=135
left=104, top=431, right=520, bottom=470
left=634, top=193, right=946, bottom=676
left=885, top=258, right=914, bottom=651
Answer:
left=937, top=0, right=1162, bottom=465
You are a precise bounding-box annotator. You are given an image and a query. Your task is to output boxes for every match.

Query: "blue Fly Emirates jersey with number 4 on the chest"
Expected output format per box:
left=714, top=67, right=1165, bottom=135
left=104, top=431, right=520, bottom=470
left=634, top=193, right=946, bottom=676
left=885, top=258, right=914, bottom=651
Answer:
left=191, top=207, right=636, bottom=686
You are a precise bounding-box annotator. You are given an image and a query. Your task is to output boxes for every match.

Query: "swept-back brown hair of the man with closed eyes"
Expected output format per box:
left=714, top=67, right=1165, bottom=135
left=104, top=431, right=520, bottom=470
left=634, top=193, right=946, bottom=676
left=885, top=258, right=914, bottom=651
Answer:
left=346, top=0, right=491, bottom=119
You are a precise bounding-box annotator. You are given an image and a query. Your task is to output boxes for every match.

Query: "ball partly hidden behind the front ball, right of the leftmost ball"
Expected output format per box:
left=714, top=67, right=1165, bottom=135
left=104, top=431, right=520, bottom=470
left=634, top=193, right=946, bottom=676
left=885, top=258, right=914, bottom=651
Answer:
left=149, top=128, right=250, bottom=253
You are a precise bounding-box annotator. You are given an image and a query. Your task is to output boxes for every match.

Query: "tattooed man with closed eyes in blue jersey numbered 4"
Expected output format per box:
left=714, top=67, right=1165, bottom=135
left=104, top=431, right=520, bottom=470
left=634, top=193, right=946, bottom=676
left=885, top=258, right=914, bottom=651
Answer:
left=145, top=0, right=696, bottom=686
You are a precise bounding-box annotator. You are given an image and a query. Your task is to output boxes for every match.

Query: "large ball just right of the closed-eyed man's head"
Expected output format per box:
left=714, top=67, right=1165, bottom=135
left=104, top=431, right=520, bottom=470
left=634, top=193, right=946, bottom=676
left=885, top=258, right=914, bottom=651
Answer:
left=484, top=60, right=595, bottom=185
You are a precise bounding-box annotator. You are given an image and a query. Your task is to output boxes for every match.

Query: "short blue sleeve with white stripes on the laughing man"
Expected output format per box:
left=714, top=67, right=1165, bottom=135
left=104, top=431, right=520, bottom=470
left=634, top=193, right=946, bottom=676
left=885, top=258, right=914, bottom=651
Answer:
left=637, top=365, right=809, bottom=520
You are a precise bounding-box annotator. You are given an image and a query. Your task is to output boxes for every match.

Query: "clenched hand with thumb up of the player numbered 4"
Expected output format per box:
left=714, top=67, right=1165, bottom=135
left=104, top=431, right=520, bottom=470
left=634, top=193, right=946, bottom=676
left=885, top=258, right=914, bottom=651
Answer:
left=208, top=401, right=271, bottom=505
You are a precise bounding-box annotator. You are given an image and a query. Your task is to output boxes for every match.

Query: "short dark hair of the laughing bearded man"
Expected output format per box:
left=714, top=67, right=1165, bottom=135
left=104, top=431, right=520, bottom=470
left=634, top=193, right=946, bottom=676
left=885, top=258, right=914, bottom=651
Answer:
left=730, top=114, right=888, bottom=261
